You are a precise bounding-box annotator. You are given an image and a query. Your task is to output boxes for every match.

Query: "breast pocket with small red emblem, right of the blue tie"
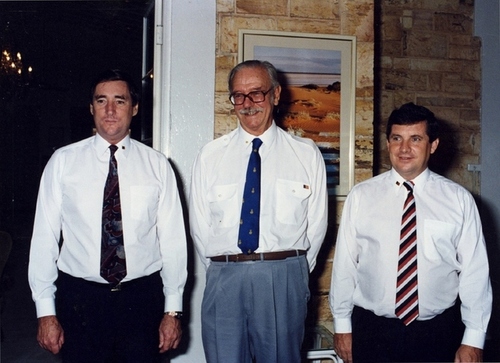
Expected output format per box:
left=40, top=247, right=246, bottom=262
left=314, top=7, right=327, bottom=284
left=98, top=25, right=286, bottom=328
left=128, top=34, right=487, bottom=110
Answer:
left=276, top=179, right=311, bottom=225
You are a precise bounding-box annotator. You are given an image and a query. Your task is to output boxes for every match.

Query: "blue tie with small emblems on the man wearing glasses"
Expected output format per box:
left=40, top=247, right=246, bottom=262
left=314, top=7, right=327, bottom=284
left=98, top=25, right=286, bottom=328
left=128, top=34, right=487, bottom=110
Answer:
left=238, top=138, right=262, bottom=255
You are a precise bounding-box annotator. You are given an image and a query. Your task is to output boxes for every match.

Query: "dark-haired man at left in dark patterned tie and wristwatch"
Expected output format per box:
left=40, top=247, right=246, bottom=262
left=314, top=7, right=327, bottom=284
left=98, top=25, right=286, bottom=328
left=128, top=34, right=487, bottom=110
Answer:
left=29, top=70, right=187, bottom=363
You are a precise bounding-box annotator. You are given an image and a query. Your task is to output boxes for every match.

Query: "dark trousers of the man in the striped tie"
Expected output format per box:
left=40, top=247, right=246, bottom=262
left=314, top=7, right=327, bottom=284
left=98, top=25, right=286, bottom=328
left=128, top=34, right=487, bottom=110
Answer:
left=352, top=304, right=464, bottom=363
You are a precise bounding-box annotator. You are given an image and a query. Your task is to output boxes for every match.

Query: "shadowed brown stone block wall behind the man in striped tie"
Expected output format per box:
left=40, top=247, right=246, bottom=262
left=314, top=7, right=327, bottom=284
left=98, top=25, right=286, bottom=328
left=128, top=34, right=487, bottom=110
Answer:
left=375, top=0, right=481, bottom=194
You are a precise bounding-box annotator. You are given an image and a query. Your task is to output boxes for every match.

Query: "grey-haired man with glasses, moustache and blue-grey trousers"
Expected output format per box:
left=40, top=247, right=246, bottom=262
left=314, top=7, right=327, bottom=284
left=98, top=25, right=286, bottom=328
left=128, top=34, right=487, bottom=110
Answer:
left=189, top=60, right=327, bottom=363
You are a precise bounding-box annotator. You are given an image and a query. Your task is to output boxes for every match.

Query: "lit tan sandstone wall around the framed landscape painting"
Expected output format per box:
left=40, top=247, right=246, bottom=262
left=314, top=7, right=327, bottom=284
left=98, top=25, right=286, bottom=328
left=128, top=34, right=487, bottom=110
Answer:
left=214, top=0, right=374, bottom=324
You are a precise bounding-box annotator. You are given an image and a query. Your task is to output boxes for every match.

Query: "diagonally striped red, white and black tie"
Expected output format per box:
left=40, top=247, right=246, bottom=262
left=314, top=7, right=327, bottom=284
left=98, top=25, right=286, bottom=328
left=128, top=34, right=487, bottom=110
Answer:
left=396, top=182, right=418, bottom=325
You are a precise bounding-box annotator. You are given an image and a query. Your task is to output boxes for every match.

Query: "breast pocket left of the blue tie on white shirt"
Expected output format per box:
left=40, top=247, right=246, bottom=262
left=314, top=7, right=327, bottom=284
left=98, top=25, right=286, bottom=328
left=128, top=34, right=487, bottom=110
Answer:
left=208, top=184, right=241, bottom=229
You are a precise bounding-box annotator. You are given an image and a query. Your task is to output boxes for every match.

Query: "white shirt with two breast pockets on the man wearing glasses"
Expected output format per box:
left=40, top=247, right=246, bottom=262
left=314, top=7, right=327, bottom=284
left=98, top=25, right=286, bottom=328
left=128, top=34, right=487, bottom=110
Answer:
left=189, top=122, right=327, bottom=271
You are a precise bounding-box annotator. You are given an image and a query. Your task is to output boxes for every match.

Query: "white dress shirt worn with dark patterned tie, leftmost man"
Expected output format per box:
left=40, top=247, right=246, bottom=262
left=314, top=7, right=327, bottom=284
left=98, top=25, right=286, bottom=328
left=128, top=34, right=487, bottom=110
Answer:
left=28, top=135, right=187, bottom=317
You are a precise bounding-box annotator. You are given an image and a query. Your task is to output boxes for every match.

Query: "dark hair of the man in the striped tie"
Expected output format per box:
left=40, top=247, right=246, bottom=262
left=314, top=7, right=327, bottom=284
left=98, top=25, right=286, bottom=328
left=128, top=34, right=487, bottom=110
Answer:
left=385, top=102, right=439, bottom=142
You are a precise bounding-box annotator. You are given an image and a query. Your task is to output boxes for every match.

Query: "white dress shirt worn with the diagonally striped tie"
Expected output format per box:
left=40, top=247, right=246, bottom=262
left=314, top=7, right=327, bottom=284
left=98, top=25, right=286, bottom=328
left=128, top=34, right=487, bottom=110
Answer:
left=330, top=169, right=492, bottom=348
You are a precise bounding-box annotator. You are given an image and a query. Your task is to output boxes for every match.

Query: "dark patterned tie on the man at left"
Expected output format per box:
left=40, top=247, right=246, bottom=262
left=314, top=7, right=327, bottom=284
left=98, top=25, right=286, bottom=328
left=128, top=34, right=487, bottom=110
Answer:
left=101, top=145, right=127, bottom=284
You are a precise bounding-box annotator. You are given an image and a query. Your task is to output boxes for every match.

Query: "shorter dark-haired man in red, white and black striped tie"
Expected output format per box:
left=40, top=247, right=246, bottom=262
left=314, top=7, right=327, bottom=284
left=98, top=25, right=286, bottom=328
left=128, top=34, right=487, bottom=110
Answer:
left=330, top=103, right=492, bottom=363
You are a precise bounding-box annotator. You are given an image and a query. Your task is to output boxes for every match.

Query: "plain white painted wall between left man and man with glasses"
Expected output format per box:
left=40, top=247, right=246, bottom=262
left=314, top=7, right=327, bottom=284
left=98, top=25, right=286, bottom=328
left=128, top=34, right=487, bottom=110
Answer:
left=160, top=0, right=216, bottom=363
